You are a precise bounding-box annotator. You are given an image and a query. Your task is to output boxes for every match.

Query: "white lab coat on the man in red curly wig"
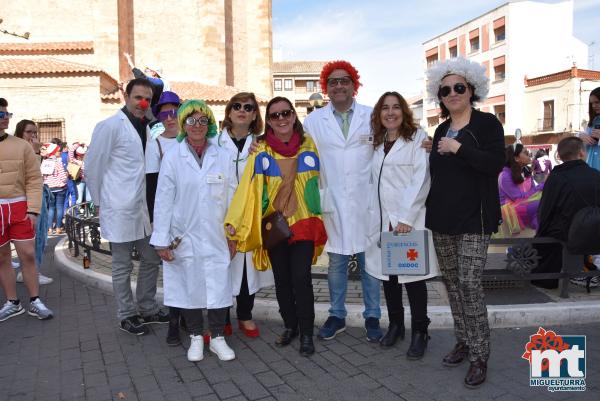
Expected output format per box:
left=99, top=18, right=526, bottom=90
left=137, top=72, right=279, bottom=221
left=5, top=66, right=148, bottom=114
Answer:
left=304, top=102, right=373, bottom=255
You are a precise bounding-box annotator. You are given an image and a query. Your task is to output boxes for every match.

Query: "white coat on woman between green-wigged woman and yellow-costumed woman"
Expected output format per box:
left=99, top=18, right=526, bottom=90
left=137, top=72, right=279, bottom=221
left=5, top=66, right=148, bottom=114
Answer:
left=210, top=128, right=275, bottom=296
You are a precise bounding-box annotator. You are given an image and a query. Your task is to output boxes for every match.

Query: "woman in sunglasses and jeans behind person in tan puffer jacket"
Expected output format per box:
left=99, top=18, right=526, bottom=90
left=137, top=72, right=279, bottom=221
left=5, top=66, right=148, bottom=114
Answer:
left=15, top=120, right=54, bottom=285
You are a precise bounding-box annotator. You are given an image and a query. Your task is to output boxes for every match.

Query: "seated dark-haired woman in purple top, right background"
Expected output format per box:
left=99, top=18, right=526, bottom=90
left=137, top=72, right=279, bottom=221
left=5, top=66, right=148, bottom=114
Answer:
left=498, top=143, right=544, bottom=237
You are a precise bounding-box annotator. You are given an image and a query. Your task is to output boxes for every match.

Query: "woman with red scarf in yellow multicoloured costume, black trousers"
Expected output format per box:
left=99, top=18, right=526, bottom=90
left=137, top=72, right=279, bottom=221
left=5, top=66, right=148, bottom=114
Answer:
left=225, top=97, right=327, bottom=356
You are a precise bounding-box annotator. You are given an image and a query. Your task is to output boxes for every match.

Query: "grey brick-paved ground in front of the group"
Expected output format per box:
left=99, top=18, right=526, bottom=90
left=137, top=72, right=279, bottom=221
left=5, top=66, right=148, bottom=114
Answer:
left=0, top=239, right=600, bottom=401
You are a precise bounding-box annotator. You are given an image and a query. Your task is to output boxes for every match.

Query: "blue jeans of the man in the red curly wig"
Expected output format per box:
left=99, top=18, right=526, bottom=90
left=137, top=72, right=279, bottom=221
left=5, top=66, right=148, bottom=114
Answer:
left=327, top=252, right=381, bottom=319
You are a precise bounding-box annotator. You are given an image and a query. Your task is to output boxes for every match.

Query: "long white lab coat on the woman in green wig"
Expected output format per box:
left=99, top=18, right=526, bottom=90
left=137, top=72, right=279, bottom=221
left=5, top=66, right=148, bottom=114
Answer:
left=150, top=141, right=235, bottom=309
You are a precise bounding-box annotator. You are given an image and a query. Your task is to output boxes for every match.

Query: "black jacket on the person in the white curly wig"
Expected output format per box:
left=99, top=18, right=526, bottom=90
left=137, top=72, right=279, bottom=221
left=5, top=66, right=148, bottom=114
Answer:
left=425, top=109, right=505, bottom=234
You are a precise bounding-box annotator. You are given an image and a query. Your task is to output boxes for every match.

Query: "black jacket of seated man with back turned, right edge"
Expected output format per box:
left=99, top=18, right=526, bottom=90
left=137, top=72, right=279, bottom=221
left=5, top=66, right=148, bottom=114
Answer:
left=536, top=160, right=600, bottom=241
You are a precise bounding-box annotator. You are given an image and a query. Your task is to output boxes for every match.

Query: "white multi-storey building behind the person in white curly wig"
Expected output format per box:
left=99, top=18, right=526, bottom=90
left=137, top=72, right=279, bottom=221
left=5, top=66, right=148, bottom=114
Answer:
left=422, top=0, right=588, bottom=141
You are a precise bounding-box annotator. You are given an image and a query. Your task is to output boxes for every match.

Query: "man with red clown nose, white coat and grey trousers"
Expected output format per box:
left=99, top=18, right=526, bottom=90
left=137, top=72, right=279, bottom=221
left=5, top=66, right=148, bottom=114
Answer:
left=85, top=78, right=169, bottom=335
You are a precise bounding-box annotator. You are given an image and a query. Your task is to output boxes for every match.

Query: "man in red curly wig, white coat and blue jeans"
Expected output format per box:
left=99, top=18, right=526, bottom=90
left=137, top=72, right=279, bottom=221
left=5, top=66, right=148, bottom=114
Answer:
left=304, top=61, right=383, bottom=342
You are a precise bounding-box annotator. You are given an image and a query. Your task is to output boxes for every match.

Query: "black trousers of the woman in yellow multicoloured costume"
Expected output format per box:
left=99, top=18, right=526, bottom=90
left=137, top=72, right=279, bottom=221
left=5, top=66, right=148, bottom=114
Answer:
left=269, top=241, right=315, bottom=335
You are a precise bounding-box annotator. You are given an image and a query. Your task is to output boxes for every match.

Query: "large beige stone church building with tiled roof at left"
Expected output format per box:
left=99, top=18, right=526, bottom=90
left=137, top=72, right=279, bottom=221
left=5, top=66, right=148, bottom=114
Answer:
left=0, top=0, right=272, bottom=142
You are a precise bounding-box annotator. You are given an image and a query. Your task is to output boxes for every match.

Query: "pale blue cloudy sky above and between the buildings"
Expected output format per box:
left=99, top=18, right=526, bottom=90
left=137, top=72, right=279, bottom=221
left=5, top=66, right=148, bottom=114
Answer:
left=273, top=0, right=600, bottom=104
